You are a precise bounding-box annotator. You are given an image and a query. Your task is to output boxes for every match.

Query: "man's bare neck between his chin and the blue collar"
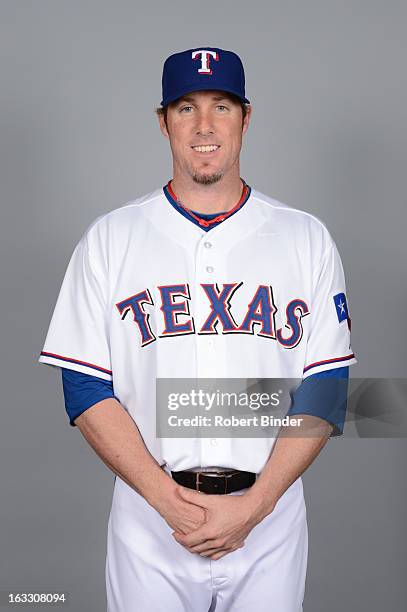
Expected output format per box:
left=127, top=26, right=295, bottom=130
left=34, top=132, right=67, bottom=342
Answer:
left=171, top=171, right=243, bottom=214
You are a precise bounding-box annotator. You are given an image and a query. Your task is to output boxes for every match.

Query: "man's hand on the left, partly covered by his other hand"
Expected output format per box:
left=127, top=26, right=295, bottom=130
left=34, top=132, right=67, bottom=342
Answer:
left=150, top=480, right=206, bottom=535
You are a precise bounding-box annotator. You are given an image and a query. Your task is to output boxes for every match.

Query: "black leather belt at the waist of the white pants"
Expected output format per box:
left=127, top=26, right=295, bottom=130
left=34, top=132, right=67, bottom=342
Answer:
left=171, top=470, right=256, bottom=495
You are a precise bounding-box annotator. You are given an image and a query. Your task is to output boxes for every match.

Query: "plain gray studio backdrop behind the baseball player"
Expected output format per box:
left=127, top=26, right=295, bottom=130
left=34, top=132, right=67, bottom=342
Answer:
left=0, top=0, right=407, bottom=612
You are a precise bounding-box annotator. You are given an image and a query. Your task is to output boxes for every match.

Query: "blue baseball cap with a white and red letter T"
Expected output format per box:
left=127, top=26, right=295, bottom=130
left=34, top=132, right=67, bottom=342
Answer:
left=161, top=47, right=250, bottom=106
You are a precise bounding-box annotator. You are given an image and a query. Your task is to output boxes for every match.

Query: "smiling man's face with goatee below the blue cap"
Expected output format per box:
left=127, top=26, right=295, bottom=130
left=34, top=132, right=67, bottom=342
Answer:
left=159, top=91, right=251, bottom=185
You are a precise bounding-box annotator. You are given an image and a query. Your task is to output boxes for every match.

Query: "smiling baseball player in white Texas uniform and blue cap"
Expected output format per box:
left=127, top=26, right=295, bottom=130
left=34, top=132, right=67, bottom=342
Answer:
left=40, top=47, right=356, bottom=612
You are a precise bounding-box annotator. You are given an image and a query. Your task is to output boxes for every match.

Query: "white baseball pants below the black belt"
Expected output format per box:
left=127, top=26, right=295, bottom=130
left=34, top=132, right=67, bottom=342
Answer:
left=106, top=477, right=308, bottom=612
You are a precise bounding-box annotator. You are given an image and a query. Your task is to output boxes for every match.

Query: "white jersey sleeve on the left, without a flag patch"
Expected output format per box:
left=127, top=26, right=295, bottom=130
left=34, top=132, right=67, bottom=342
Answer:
left=39, top=234, right=112, bottom=381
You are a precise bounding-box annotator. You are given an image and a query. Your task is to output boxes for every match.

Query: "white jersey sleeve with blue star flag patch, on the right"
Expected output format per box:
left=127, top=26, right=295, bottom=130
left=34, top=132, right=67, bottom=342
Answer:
left=303, top=235, right=357, bottom=378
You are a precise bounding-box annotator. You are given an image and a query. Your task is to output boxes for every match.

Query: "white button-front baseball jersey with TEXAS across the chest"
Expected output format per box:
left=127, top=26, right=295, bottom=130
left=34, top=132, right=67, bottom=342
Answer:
left=40, top=189, right=356, bottom=473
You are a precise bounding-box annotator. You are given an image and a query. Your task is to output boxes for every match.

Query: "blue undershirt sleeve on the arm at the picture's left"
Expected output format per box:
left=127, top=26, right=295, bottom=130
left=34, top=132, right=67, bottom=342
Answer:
left=61, top=368, right=117, bottom=427
